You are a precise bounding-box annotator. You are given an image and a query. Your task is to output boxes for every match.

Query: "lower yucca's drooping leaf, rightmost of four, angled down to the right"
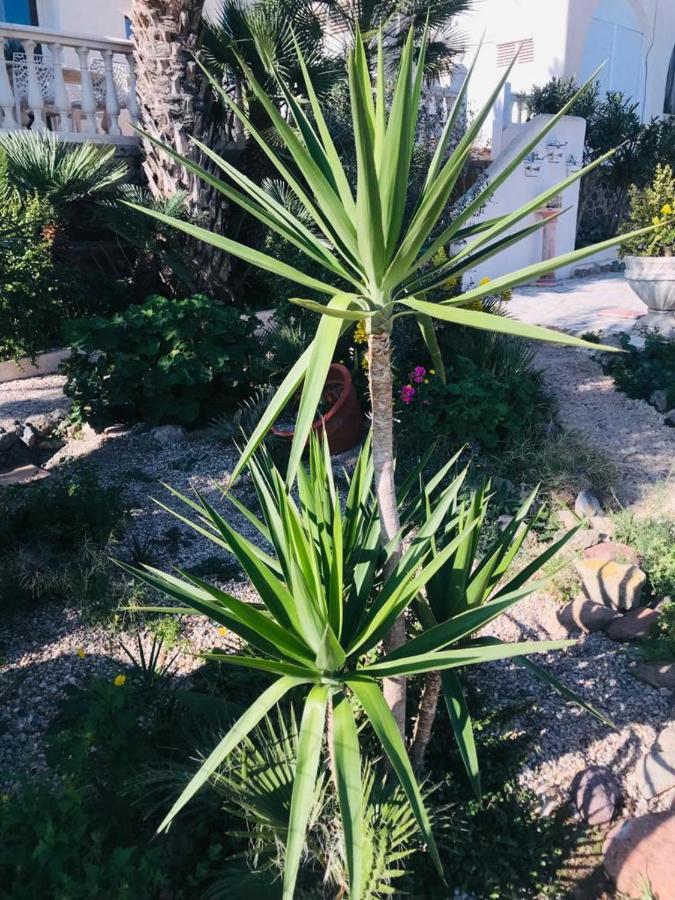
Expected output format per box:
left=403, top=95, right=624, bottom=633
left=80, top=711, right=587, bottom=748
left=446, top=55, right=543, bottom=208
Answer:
left=347, top=676, right=443, bottom=877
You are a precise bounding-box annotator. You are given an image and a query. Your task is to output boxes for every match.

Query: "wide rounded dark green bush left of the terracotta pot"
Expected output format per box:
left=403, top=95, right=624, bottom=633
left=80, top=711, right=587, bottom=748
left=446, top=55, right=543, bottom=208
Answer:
left=64, top=294, right=253, bottom=427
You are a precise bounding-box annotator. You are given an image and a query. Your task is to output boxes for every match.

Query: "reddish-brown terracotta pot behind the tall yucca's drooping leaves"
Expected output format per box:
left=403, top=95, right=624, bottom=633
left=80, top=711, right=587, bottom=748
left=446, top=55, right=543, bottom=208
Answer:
left=272, top=363, right=363, bottom=454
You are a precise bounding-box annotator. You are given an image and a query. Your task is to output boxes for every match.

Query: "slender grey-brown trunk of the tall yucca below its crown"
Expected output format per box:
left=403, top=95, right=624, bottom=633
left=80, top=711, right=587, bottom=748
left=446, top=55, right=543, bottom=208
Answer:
left=368, top=331, right=406, bottom=736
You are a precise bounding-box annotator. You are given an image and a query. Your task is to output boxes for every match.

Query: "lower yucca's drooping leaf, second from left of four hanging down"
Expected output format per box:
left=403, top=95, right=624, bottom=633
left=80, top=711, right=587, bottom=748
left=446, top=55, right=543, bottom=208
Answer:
left=283, top=684, right=328, bottom=900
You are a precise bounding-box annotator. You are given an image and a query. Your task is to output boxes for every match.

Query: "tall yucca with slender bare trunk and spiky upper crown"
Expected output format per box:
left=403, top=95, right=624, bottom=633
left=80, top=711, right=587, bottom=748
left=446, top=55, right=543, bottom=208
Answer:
left=128, top=31, right=660, bottom=729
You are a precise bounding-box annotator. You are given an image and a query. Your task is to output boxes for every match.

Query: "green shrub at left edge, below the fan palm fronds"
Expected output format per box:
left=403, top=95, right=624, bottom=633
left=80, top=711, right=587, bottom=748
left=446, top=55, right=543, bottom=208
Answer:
left=0, top=193, right=94, bottom=360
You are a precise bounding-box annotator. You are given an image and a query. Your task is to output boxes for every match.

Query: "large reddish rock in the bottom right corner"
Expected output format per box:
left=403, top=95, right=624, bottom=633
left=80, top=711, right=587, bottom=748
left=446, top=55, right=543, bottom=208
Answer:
left=602, top=811, right=675, bottom=900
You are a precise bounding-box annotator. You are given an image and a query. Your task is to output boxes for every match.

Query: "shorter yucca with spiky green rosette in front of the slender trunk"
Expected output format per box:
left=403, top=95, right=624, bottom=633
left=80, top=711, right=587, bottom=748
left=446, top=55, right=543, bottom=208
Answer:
left=123, top=437, right=596, bottom=900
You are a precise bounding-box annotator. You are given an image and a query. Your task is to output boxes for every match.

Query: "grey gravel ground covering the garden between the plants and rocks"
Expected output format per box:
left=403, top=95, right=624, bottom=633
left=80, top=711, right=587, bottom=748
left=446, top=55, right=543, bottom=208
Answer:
left=0, top=368, right=675, bottom=812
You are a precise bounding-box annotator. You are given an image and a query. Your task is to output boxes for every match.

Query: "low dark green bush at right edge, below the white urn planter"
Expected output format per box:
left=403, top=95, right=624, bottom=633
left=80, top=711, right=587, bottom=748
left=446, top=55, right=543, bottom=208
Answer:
left=605, top=331, right=675, bottom=408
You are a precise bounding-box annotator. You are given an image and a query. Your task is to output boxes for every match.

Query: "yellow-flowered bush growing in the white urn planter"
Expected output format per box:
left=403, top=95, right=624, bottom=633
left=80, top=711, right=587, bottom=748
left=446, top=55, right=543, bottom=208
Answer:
left=623, top=164, right=675, bottom=256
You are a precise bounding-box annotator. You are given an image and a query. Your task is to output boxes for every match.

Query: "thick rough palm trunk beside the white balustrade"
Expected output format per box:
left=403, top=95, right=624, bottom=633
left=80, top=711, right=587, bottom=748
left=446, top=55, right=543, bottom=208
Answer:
left=129, top=0, right=231, bottom=291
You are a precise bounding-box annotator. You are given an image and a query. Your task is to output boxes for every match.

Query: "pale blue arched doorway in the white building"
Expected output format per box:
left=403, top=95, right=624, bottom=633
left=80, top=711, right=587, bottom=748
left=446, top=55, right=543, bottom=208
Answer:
left=579, top=0, right=645, bottom=110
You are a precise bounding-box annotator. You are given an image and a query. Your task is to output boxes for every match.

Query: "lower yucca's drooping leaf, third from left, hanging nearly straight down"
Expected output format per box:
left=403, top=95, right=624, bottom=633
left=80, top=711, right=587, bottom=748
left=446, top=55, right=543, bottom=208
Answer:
left=333, top=694, right=364, bottom=900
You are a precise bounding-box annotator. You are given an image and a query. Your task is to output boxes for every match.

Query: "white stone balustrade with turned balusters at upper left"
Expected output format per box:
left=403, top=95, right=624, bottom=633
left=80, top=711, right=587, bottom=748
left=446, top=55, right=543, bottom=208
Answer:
left=0, top=22, right=138, bottom=144
